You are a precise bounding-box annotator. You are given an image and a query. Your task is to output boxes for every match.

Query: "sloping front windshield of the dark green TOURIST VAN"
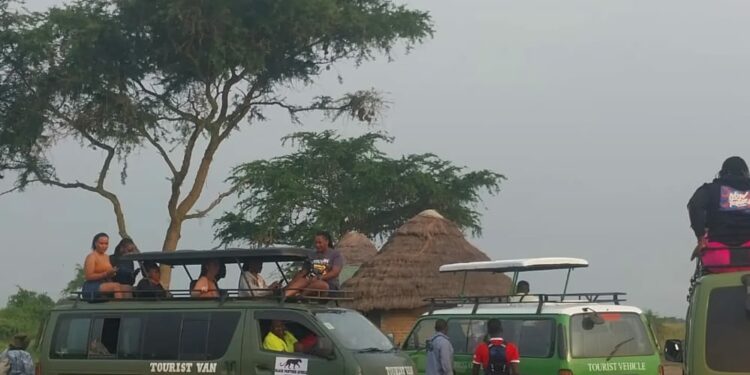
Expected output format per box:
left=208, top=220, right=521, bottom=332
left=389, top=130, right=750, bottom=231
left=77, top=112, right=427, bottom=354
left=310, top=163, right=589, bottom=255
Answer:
left=315, top=310, right=393, bottom=352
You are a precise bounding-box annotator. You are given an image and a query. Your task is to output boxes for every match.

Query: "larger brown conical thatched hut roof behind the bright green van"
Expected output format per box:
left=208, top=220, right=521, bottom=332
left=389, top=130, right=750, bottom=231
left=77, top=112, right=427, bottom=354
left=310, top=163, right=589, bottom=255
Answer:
left=342, top=210, right=510, bottom=311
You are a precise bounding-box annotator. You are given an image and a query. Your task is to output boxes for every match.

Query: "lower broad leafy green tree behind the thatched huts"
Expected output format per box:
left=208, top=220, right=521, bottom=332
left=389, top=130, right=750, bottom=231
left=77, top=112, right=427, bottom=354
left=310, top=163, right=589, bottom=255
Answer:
left=215, top=131, right=504, bottom=246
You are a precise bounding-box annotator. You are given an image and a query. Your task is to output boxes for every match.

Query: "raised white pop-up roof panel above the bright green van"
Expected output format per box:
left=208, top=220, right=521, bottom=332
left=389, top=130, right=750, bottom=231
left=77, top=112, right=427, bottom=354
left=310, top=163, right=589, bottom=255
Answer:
left=440, top=257, right=589, bottom=272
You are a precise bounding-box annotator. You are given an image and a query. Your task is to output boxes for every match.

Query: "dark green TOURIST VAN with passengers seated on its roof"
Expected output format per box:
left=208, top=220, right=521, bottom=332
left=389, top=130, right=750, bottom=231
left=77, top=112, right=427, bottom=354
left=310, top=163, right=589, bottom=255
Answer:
left=37, top=248, right=415, bottom=375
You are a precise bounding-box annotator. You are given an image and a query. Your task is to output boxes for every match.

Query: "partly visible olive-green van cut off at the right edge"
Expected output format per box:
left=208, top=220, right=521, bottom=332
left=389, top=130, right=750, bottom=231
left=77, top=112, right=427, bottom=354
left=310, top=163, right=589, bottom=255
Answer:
left=664, top=264, right=750, bottom=375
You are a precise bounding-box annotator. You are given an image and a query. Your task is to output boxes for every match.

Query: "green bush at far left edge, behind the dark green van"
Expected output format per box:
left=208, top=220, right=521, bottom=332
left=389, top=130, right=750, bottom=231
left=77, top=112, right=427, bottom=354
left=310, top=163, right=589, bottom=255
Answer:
left=0, top=287, right=55, bottom=348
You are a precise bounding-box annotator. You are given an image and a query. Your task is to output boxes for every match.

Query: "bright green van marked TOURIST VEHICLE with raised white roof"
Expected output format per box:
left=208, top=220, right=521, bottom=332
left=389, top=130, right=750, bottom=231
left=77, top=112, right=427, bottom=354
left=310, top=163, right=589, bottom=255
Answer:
left=402, top=258, right=664, bottom=375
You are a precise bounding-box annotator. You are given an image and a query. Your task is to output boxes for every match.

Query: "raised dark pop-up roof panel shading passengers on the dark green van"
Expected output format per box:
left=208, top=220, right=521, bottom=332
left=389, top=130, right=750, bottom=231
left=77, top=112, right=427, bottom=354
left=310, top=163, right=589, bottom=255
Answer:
left=121, top=247, right=315, bottom=266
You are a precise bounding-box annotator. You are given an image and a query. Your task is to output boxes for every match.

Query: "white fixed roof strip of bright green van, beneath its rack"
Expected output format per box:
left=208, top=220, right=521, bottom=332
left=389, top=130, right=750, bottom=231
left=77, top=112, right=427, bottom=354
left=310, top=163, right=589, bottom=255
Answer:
left=423, top=302, right=643, bottom=316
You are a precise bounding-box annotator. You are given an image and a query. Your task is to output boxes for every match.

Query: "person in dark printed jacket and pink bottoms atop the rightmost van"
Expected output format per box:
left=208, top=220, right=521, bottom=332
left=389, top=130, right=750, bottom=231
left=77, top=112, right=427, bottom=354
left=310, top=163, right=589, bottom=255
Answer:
left=688, top=156, right=750, bottom=272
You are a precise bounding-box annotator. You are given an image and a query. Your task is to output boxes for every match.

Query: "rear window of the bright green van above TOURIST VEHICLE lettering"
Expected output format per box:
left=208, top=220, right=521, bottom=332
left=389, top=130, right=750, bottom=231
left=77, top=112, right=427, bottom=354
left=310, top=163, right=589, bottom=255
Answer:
left=570, top=312, right=654, bottom=358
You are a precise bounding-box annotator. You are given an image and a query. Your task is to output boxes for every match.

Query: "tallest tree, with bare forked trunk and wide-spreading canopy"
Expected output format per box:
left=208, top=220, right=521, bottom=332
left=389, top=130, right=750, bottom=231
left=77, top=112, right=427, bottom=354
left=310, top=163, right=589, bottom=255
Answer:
left=0, top=0, right=432, bottom=284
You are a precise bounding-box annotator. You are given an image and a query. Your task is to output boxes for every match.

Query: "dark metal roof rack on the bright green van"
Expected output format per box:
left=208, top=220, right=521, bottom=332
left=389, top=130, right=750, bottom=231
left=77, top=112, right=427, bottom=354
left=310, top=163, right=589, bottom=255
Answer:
left=425, top=292, right=627, bottom=315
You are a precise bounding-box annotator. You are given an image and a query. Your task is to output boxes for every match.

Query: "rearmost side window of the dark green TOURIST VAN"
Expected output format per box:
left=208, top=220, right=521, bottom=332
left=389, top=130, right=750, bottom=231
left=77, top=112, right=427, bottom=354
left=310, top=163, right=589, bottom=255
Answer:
left=49, top=317, right=91, bottom=359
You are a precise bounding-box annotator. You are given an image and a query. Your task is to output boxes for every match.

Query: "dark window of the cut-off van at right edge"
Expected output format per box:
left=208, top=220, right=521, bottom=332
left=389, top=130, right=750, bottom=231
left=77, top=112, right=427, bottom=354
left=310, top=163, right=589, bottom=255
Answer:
left=706, top=286, right=750, bottom=374
